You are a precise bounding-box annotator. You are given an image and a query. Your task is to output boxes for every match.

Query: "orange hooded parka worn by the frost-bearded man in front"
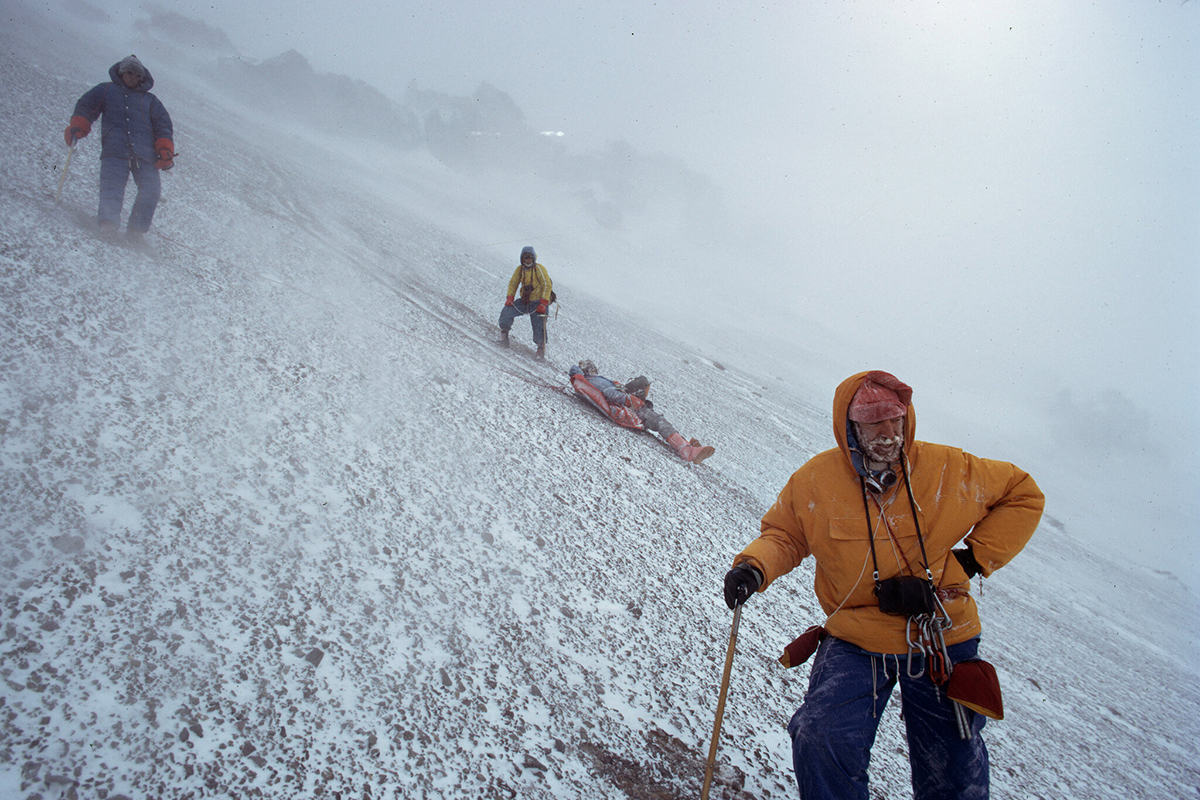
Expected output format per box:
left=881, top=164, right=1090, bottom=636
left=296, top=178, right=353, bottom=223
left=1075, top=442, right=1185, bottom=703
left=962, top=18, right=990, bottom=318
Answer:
left=733, top=372, right=1045, bottom=654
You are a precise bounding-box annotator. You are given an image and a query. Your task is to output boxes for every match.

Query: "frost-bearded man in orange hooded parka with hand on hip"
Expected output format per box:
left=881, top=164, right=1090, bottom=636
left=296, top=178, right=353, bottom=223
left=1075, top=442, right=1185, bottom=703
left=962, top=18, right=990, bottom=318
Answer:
left=725, top=371, right=1045, bottom=800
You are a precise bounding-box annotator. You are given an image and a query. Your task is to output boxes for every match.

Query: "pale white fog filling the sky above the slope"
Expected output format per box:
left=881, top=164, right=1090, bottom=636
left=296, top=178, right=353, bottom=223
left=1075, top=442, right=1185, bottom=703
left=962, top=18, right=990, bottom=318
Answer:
left=44, top=0, right=1200, bottom=588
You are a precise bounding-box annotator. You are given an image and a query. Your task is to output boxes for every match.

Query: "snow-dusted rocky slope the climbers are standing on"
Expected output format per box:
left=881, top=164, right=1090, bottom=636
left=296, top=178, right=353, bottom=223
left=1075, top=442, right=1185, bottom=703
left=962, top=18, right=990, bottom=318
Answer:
left=0, top=4, right=1200, bottom=800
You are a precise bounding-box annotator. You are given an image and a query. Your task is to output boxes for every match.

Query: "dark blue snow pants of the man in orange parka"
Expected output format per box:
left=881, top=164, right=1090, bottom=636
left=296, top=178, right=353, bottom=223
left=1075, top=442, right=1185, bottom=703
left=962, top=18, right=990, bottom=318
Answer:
left=787, top=636, right=989, bottom=800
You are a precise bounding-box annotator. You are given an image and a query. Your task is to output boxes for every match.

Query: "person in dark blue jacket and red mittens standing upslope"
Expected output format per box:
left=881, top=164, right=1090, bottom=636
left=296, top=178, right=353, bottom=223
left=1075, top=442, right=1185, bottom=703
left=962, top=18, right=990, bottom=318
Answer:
left=62, top=55, right=175, bottom=239
